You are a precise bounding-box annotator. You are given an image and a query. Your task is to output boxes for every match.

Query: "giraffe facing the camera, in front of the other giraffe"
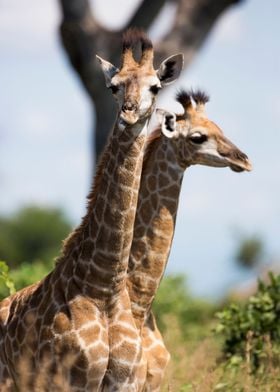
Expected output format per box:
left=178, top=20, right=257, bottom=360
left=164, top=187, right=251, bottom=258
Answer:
left=0, top=30, right=183, bottom=391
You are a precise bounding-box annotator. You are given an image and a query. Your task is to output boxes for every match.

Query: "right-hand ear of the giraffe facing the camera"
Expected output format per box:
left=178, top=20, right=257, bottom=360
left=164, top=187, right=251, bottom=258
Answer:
left=157, top=53, right=184, bottom=86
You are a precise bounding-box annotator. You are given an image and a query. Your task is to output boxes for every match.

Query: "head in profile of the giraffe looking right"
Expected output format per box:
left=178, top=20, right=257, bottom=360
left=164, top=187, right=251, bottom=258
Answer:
left=157, top=90, right=252, bottom=172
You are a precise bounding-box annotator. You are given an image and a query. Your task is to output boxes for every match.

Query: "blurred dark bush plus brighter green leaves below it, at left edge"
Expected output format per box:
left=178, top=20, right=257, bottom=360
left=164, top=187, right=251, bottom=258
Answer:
left=0, top=206, right=71, bottom=299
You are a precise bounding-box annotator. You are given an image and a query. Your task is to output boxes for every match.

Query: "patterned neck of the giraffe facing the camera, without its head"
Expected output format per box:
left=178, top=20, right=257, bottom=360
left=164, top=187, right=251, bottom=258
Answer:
left=58, top=120, right=147, bottom=300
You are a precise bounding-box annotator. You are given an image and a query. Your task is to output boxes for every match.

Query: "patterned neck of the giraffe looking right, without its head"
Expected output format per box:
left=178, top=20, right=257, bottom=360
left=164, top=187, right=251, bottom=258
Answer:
left=127, top=137, right=187, bottom=328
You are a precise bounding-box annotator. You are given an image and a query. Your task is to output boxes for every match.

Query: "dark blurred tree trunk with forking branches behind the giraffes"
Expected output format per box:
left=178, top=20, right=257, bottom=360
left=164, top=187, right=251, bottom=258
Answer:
left=58, top=0, right=242, bottom=165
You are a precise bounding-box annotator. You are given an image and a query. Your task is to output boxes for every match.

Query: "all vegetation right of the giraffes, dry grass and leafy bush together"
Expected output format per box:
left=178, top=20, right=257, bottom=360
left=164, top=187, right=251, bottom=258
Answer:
left=153, top=275, right=280, bottom=392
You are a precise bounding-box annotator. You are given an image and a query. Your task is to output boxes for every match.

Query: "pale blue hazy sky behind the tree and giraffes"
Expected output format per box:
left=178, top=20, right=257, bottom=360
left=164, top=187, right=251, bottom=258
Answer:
left=0, top=0, right=280, bottom=297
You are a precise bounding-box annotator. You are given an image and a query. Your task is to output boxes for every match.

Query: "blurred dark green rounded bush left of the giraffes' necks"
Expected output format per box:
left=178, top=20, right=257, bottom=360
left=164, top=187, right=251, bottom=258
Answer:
left=0, top=206, right=71, bottom=268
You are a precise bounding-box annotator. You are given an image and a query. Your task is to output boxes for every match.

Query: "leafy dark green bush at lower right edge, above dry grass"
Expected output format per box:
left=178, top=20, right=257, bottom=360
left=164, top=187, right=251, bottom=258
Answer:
left=216, top=273, right=280, bottom=370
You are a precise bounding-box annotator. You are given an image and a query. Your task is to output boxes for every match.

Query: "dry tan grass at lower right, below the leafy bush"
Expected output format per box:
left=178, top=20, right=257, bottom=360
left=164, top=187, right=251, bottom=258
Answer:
left=162, top=316, right=280, bottom=392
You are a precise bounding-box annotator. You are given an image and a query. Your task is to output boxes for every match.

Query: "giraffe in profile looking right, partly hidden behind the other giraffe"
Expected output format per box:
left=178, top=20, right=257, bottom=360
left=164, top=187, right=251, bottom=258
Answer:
left=127, top=90, right=251, bottom=391
